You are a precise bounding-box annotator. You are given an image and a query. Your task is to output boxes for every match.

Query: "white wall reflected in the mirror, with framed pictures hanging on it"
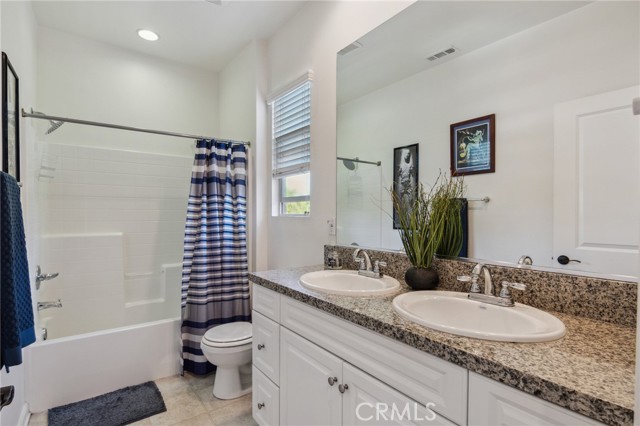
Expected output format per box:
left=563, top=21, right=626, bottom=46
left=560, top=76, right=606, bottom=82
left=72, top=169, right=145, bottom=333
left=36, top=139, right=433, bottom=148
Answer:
left=338, top=2, right=640, bottom=266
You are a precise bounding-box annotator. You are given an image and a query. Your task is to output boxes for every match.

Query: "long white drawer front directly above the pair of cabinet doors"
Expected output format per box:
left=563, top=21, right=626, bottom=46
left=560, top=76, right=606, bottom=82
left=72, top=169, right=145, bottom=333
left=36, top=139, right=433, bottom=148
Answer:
left=280, top=297, right=468, bottom=425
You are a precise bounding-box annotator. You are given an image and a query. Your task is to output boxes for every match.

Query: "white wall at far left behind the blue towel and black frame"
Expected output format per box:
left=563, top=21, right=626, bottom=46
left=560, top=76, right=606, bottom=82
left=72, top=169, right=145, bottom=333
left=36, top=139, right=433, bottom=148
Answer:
left=0, top=2, right=38, bottom=425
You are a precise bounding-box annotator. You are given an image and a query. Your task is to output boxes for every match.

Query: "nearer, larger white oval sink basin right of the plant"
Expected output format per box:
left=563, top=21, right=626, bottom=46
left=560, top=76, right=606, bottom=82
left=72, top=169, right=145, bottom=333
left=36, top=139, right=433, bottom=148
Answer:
left=393, top=291, right=565, bottom=342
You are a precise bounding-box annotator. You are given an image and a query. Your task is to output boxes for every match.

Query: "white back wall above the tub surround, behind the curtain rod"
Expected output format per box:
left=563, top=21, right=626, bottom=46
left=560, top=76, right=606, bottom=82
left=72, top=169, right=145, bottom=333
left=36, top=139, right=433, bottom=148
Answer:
left=37, top=28, right=219, bottom=156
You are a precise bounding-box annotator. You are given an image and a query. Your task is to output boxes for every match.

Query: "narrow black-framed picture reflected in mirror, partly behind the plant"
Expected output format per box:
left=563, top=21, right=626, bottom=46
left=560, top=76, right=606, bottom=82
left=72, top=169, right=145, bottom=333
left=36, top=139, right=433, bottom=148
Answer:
left=393, top=143, right=419, bottom=229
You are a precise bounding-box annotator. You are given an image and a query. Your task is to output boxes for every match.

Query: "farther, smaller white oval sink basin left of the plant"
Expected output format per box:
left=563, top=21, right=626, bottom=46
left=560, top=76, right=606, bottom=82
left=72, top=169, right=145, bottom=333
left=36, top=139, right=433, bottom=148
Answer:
left=300, top=271, right=400, bottom=296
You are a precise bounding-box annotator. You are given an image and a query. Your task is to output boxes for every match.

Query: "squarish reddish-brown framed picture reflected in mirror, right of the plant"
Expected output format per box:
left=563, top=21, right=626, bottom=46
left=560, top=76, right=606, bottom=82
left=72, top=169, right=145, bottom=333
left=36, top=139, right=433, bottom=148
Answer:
left=450, top=114, right=496, bottom=176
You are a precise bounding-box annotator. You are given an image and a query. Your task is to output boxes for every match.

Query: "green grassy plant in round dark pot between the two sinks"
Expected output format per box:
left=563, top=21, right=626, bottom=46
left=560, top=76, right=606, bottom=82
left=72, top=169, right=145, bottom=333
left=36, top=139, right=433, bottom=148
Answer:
left=390, top=175, right=464, bottom=290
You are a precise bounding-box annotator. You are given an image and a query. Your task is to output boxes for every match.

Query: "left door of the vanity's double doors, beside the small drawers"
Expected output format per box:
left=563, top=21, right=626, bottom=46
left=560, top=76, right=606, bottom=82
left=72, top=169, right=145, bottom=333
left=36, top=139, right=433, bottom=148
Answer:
left=280, top=328, right=342, bottom=426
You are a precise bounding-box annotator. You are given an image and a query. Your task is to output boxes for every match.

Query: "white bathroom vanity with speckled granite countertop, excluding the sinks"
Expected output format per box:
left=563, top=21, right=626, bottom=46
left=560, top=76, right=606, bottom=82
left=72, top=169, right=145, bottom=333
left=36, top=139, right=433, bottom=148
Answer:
left=251, top=266, right=635, bottom=425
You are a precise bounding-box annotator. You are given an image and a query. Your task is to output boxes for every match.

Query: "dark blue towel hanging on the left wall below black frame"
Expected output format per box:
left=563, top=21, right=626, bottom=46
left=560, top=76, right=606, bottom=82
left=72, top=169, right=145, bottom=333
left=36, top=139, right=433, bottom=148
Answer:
left=0, top=172, right=36, bottom=371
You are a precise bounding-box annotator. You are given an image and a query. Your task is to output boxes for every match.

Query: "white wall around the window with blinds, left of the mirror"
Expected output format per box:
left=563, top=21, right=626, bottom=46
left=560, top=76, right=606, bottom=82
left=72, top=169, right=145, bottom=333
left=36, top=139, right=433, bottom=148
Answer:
left=265, top=1, right=412, bottom=268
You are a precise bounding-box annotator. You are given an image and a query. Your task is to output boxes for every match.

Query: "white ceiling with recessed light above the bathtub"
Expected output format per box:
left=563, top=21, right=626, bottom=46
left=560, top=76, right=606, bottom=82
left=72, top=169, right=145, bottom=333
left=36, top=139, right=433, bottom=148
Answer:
left=32, top=0, right=305, bottom=71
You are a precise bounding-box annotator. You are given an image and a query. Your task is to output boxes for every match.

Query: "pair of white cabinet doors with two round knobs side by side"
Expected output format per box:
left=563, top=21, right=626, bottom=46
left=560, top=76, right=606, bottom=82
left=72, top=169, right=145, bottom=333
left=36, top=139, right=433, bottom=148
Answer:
left=280, top=329, right=454, bottom=426
